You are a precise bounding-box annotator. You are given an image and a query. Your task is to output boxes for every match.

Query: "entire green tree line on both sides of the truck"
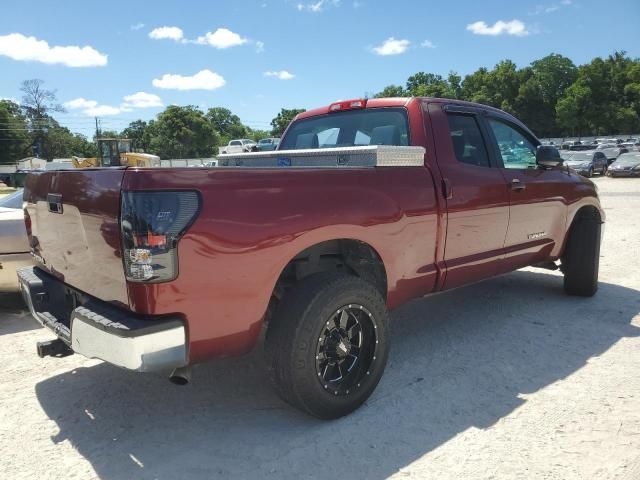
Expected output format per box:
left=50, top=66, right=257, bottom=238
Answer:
left=0, top=52, right=640, bottom=163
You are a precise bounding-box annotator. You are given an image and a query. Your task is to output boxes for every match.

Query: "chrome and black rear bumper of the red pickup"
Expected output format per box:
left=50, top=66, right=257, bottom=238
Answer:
left=17, top=267, right=187, bottom=372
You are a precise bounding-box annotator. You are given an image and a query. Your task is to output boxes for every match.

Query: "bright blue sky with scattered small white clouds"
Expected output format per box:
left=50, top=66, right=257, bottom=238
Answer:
left=0, top=0, right=640, bottom=135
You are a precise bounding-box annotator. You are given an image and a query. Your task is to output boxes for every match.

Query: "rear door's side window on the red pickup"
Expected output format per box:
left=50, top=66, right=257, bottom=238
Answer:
left=447, top=113, right=490, bottom=167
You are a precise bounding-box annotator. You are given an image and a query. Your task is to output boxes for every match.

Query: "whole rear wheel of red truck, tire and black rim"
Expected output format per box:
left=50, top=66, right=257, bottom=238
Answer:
left=265, top=273, right=389, bottom=419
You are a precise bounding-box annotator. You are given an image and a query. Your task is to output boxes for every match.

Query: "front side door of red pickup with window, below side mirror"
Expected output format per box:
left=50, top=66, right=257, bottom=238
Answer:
left=485, top=113, right=567, bottom=272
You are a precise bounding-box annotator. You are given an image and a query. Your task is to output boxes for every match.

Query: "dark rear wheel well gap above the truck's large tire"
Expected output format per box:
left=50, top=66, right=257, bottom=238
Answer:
left=266, top=239, right=387, bottom=321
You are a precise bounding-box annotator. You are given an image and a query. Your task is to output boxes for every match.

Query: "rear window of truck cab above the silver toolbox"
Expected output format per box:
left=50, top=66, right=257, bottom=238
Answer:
left=280, top=108, right=409, bottom=150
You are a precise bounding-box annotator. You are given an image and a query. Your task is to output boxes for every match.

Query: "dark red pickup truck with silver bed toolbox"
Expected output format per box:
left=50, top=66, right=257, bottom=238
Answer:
left=19, top=98, right=604, bottom=418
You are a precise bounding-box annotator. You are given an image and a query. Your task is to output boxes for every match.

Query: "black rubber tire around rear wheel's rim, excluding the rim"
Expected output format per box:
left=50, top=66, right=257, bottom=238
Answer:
left=265, top=273, right=389, bottom=419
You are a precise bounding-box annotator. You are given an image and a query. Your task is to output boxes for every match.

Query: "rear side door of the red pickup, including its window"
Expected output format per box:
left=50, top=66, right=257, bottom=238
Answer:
left=428, top=103, right=509, bottom=289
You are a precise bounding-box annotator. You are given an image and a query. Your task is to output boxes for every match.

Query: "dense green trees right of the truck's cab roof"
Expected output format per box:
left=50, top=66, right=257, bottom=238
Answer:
left=375, top=52, right=640, bottom=138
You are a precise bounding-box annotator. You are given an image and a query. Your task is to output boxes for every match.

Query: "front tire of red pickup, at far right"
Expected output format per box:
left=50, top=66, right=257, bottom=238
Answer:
left=562, top=214, right=602, bottom=297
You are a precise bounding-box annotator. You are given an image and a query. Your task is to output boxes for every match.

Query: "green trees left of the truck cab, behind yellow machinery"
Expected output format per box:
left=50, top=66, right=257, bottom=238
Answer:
left=0, top=79, right=304, bottom=164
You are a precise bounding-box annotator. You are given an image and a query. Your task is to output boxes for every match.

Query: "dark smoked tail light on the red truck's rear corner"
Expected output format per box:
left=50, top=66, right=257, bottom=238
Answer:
left=120, top=191, right=200, bottom=283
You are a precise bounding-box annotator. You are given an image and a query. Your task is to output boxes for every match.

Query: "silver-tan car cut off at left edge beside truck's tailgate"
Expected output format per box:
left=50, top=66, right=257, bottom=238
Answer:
left=0, top=189, right=33, bottom=291
